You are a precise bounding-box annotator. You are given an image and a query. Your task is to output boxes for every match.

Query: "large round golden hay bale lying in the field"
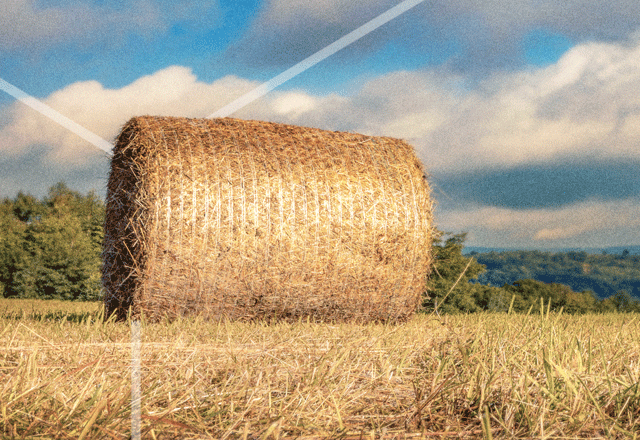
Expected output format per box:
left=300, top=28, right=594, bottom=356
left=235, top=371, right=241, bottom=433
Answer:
left=102, top=116, right=433, bottom=322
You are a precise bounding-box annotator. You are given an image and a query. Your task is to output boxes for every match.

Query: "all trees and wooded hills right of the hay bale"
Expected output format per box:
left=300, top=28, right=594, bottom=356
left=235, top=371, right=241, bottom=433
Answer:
left=424, top=234, right=640, bottom=313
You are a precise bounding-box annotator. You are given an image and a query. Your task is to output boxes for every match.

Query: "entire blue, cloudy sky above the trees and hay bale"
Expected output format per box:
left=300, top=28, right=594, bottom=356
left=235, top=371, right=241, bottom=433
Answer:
left=0, top=0, right=640, bottom=250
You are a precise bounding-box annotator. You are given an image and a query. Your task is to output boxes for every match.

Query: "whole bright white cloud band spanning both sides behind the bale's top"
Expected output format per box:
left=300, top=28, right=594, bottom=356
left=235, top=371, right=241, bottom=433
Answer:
left=0, top=32, right=640, bottom=171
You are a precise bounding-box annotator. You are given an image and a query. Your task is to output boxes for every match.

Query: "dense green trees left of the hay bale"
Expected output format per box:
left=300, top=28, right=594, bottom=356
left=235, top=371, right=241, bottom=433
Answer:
left=0, top=183, right=104, bottom=300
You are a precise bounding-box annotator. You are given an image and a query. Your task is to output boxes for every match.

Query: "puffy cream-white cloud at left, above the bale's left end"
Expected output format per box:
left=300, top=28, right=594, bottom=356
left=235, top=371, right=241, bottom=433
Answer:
left=0, top=66, right=255, bottom=162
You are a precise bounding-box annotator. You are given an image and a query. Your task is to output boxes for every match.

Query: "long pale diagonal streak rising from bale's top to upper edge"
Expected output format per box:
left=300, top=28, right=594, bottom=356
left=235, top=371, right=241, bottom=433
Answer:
left=208, top=0, right=424, bottom=118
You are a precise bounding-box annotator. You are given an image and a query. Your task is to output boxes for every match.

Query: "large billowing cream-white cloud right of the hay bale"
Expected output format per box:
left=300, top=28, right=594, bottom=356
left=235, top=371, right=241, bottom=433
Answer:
left=359, top=39, right=640, bottom=171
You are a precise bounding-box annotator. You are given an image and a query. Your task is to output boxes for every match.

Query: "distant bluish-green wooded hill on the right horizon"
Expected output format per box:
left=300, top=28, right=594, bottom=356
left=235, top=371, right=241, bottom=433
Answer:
left=465, top=251, right=640, bottom=298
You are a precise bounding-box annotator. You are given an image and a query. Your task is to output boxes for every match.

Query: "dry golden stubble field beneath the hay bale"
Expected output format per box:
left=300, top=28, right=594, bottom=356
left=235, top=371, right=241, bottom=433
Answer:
left=0, top=299, right=640, bottom=439
